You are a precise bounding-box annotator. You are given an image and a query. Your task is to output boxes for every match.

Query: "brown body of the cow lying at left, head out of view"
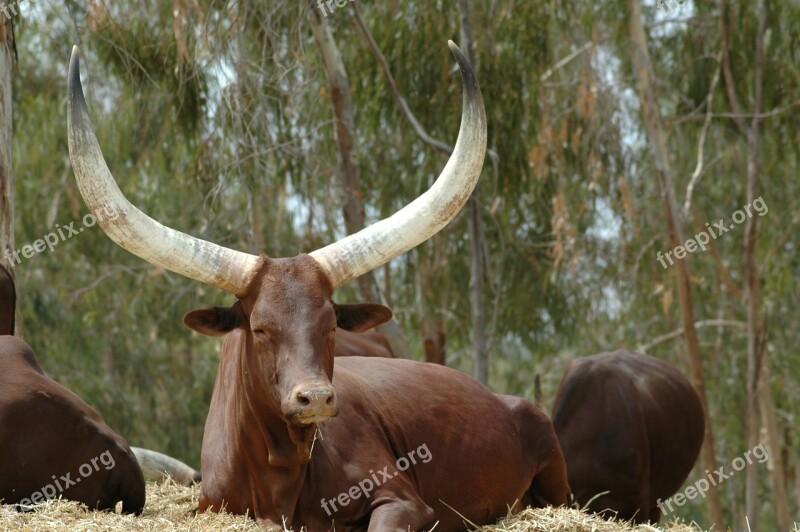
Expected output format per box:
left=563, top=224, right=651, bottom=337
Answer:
left=0, top=336, right=145, bottom=514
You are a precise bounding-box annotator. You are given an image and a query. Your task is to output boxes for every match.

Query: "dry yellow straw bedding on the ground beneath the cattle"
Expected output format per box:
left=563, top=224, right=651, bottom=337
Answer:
left=0, top=481, right=700, bottom=532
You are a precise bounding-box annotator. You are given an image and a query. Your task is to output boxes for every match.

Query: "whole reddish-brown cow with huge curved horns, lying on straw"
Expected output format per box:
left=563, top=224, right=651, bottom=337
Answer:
left=68, top=42, right=569, bottom=531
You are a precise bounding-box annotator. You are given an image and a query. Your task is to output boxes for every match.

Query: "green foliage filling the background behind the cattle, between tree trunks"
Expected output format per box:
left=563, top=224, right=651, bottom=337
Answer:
left=4, top=0, right=800, bottom=529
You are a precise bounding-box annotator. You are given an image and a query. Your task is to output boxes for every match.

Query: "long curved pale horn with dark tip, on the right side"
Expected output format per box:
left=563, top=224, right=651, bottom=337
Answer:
left=310, top=41, right=486, bottom=288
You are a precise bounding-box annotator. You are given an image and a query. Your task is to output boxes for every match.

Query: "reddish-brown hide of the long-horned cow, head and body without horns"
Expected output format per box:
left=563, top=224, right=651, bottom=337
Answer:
left=193, top=255, right=569, bottom=532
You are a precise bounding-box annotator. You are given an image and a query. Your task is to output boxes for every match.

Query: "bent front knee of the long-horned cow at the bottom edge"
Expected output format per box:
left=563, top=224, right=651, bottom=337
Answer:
left=369, top=493, right=436, bottom=532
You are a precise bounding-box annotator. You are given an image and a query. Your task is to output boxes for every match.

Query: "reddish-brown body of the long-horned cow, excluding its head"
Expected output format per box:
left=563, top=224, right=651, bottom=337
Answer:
left=200, top=352, right=569, bottom=531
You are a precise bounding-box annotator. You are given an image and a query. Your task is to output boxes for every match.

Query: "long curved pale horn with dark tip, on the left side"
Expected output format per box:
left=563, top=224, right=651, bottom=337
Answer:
left=67, top=46, right=258, bottom=296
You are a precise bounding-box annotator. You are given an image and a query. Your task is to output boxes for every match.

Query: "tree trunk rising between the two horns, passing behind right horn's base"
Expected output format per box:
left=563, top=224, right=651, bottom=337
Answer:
left=308, top=2, right=409, bottom=358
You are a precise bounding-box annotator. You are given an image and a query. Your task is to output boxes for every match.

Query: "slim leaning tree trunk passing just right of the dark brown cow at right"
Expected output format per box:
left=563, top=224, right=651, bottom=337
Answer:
left=628, top=0, right=725, bottom=529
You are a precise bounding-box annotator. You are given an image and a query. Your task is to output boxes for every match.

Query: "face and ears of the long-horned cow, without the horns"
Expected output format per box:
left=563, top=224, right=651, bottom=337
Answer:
left=183, top=255, right=392, bottom=425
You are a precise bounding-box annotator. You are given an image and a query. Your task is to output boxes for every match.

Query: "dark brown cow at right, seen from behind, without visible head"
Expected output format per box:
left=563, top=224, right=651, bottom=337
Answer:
left=553, top=350, right=705, bottom=523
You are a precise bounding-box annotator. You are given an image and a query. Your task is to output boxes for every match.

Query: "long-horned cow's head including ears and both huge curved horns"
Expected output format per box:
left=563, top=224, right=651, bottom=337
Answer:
left=68, top=41, right=486, bottom=425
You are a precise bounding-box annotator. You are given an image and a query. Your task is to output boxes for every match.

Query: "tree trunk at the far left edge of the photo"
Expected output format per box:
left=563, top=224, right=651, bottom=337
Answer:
left=0, top=17, right=14, bottom=296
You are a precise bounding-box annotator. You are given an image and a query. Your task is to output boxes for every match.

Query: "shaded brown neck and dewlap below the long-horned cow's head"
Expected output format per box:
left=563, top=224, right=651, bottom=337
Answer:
left=226, top=334, right=315, bottom=518
